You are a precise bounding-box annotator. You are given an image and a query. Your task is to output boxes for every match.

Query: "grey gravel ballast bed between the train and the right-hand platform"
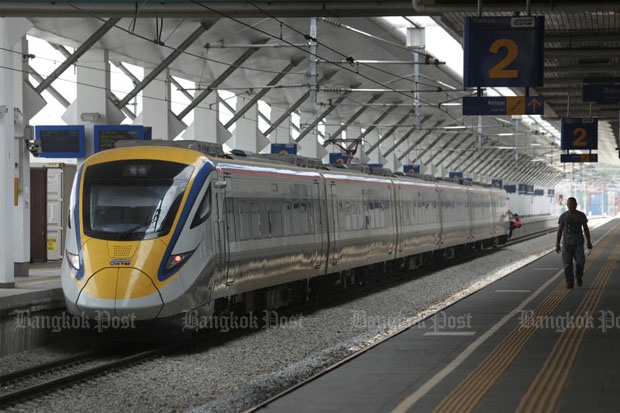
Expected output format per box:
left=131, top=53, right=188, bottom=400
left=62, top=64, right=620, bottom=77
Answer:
left=0, top=227, right=596, bottom=413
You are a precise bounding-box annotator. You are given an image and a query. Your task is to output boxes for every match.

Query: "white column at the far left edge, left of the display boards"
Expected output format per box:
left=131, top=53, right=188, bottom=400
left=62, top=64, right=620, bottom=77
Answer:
left=0, top=18, right=31, bottom=288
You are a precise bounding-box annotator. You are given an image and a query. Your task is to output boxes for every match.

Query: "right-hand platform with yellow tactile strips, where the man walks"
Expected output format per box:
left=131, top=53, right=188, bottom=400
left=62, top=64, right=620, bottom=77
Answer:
left=261, top=219, right=620, bottom=412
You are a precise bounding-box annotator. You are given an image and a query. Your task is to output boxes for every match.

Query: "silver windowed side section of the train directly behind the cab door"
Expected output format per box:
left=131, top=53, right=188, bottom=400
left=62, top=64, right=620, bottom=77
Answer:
left=209, top=164, right=327, bottom=298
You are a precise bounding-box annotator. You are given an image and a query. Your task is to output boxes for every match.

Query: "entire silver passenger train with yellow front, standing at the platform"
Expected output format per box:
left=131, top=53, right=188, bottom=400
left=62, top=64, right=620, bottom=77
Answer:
left=61, top=141, right=508, bottom=320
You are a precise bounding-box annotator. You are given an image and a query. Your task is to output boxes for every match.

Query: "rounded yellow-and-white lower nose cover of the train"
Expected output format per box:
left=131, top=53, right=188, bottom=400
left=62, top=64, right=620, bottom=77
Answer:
left=76, top=267, right=163, bottom=320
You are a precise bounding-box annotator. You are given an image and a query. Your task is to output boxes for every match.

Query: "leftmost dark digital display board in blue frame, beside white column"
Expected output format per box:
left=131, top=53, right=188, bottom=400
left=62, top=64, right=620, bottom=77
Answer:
left=35, top=125, right=86, bottom=158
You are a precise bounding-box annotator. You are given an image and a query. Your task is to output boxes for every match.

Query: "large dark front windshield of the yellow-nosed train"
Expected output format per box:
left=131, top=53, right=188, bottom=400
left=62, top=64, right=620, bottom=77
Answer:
left=82, top=160, right=194, bottom=240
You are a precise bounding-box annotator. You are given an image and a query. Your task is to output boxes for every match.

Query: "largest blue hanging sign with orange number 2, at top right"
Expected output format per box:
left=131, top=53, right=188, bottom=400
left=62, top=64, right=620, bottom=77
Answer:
left=463, top=16, right=545, bottom=87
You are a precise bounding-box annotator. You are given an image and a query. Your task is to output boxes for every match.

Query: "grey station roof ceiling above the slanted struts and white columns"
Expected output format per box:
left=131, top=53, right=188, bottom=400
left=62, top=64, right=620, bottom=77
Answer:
left=0, top=0, right=620, bottom=187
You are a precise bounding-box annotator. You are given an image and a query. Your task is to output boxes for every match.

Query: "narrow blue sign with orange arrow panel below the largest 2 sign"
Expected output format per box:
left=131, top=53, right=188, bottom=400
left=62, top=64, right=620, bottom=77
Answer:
left=463, top=96, right=545, bottom=116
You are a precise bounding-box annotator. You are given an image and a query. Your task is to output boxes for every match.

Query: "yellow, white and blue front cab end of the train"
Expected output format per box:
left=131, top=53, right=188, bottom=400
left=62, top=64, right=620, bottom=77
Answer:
left=61, top=147, right=215, bottom=320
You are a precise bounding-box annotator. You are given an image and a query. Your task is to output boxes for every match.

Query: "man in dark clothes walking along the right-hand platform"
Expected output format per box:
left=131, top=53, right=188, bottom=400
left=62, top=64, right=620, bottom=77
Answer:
left=555, top=197, right=592, bottom=288
